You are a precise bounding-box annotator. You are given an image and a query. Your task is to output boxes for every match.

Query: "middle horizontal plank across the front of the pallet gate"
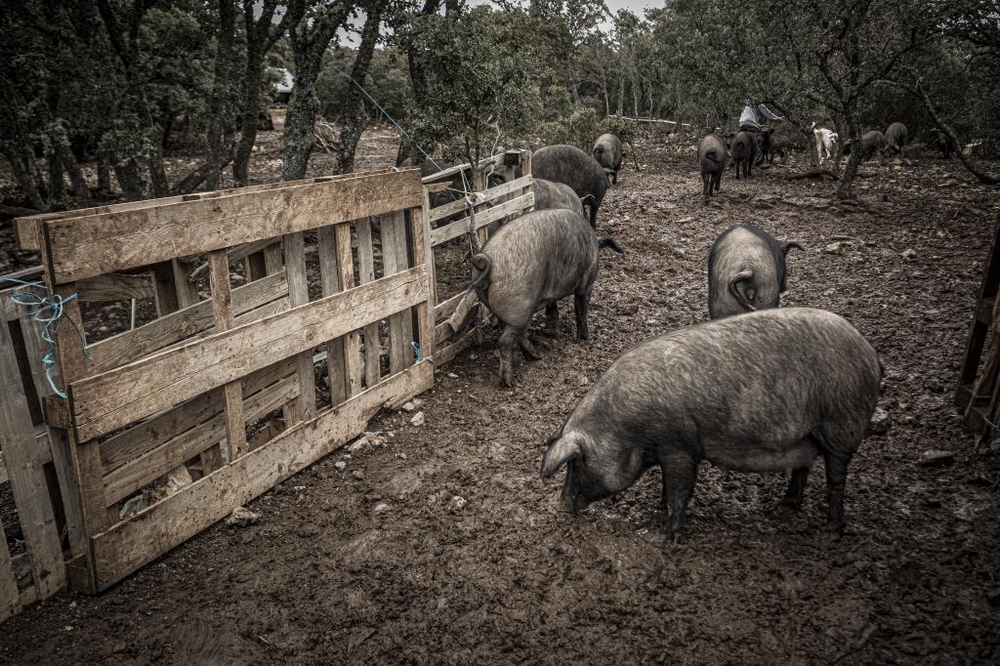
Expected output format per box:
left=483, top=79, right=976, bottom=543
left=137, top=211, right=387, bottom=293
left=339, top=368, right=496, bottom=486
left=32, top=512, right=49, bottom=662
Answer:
left=70, top=264, right=428, bottom=439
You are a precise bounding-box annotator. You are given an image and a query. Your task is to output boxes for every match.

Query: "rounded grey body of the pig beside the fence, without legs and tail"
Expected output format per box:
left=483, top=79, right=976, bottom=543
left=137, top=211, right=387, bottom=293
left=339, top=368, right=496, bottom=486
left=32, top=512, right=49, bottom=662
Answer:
left=483, top=208, right=597, bottom=326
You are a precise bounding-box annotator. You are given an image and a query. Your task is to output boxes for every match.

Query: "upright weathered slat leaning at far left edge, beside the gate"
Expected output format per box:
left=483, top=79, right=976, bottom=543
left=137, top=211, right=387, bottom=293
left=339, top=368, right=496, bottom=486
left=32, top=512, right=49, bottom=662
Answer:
left=0, top=308, right=66, bottom=599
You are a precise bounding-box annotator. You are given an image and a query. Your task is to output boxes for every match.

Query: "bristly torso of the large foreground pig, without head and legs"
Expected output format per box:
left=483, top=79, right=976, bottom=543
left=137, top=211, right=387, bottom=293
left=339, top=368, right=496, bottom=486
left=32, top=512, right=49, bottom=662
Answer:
left=564, top=308, right=881, bottom=460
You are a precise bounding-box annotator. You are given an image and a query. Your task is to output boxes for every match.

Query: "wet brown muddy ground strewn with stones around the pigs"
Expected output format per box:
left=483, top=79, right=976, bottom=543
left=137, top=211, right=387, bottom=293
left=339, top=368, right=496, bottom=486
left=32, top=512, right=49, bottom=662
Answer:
left=0, top=127, right=1000, bottom=664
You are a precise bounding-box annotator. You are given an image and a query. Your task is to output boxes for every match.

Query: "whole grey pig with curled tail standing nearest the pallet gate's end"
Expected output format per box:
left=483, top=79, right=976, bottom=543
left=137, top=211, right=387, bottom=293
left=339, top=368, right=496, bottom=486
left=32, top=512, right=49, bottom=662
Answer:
left=469, top=206, right=622, bottom=387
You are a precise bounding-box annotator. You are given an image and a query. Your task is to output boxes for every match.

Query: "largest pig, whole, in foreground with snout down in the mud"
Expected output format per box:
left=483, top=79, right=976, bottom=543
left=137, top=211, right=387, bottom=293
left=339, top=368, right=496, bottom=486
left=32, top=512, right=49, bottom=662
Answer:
left=541, top=308, right=881, bottom=533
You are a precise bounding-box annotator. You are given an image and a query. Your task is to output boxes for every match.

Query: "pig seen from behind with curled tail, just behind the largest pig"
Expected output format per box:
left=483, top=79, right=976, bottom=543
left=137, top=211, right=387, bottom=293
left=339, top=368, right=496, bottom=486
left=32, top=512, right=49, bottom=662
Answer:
left=708, top=224, right=804, bottom=319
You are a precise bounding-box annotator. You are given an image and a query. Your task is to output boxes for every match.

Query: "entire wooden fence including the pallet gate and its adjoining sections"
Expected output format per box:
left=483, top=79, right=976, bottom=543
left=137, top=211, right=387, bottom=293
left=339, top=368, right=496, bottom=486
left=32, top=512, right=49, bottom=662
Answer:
left=0, top=151, right=534, bottom=620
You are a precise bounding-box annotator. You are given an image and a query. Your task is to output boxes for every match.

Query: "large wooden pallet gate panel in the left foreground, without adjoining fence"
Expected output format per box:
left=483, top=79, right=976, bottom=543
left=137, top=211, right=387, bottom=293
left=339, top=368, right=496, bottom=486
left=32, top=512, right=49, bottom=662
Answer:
left=0, top=170, right=434, bottom=597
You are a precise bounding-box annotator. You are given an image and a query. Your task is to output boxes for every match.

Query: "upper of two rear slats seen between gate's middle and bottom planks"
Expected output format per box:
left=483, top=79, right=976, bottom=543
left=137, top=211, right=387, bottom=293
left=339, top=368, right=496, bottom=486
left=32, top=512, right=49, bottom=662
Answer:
left=101, top=359, right=295, bottom=472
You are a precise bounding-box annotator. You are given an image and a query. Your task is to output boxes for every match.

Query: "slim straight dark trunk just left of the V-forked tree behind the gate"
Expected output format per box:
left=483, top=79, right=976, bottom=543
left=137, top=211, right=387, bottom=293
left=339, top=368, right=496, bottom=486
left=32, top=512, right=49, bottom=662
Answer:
left=205, top=0, right=236, bottom=190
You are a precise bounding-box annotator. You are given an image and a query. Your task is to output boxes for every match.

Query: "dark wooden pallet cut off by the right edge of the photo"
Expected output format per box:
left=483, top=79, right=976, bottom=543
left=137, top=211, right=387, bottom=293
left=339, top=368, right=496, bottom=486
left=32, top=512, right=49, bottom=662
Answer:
left=955, top=217, right=1000, bottom=437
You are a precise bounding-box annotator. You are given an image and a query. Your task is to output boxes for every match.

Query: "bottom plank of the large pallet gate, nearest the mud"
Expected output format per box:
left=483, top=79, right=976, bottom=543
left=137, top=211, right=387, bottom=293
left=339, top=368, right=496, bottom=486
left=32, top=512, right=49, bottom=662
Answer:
left=92, top=362, right=434, bottom=590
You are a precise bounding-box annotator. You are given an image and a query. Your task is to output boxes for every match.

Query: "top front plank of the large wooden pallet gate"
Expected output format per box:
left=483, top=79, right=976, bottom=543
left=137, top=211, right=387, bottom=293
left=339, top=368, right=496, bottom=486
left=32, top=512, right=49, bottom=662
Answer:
left=42, top=169, right=421, bottom=284
